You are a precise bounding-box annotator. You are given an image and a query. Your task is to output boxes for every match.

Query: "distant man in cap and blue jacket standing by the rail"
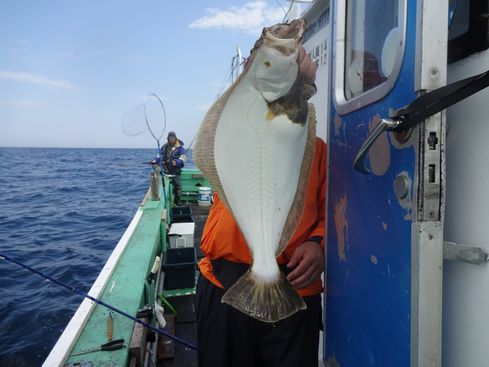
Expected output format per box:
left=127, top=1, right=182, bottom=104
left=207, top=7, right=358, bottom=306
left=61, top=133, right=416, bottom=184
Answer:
left=161, top=131, right=186, bottom=206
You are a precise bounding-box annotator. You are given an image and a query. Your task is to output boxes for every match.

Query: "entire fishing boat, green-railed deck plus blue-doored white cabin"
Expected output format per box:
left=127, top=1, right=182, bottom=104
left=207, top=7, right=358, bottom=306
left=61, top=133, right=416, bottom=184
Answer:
left=38, top=0, right=489, bottom=367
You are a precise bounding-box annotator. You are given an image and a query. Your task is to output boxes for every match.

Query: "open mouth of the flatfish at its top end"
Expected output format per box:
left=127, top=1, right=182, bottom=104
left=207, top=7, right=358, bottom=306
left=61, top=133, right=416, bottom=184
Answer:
left=262, top=19, right=305, bottom=56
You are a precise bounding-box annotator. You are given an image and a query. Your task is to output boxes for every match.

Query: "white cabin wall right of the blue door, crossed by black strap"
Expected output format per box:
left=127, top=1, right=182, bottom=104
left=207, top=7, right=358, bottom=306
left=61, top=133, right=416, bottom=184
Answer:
left=442, top=51, right=489, bottom=367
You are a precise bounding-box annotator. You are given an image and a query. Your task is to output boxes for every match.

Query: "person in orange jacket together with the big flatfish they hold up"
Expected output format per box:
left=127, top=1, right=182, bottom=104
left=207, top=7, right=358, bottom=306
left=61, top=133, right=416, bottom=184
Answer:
left=194, top=20, right=326, bottom=367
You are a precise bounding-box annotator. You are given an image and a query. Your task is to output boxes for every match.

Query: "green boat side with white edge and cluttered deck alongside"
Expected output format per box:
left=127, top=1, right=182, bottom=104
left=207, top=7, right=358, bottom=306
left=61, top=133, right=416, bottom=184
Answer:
left=43, top=165, right=211, bottom=367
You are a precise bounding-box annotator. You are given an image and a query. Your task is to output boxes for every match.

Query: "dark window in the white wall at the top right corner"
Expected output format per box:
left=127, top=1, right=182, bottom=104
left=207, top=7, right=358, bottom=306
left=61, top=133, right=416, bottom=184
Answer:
left=448, top=0, right=489, bottom=63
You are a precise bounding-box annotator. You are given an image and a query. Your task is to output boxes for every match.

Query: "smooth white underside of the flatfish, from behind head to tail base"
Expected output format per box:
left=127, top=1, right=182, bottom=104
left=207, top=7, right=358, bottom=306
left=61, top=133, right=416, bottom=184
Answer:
left=214, top=78, right=308, bottom=282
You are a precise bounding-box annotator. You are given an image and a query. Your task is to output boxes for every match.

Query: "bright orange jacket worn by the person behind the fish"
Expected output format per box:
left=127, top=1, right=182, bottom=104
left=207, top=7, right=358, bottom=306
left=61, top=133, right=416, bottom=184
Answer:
left=199, top=138, right=326, bottom=296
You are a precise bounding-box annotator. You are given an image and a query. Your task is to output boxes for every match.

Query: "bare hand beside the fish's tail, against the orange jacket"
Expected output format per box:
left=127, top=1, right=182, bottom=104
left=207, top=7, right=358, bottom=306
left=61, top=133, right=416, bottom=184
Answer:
left=287, top=241, right=324, bottom=289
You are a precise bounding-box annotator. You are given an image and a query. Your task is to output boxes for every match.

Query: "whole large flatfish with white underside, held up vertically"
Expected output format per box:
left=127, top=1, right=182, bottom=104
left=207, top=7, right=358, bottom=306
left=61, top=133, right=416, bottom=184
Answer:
left=194, top=20, right=316, bottom=322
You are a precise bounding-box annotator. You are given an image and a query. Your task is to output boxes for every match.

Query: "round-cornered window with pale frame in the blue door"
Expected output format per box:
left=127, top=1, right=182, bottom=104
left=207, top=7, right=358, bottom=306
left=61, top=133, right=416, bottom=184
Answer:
left=334, top=0, right=406, bottom=113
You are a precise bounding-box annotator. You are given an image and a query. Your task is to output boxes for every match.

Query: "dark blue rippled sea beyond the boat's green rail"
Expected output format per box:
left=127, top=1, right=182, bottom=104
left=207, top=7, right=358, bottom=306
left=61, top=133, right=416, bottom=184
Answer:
left=0, top=148, right=166, bottom=367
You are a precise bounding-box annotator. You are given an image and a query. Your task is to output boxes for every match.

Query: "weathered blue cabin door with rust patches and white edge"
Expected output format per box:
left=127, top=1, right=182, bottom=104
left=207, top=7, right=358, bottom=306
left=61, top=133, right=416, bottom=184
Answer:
left=324, top=0, right=448, bottom=367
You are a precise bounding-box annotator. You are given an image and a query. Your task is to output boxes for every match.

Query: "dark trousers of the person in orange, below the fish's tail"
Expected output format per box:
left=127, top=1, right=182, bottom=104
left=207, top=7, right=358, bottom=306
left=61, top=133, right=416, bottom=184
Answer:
left=195, top=275, right=322, bottom=367
